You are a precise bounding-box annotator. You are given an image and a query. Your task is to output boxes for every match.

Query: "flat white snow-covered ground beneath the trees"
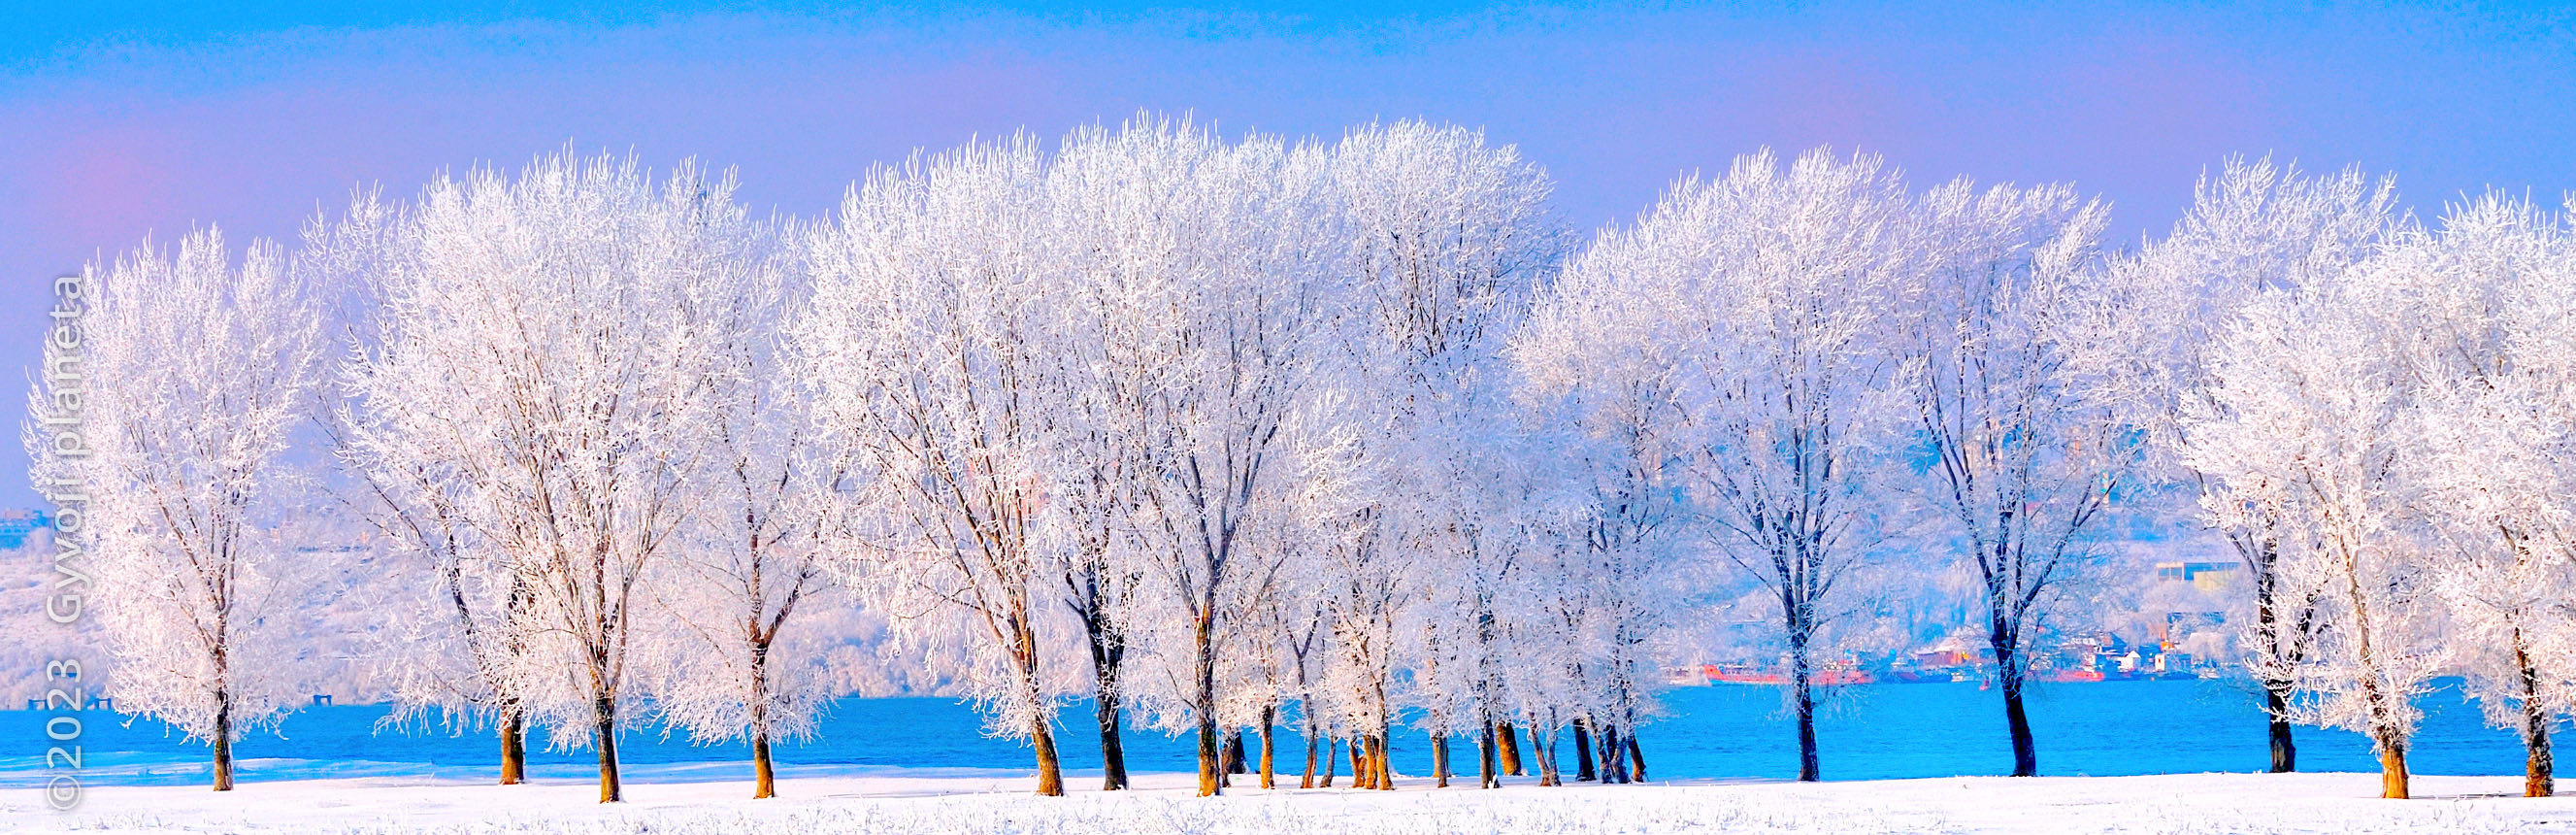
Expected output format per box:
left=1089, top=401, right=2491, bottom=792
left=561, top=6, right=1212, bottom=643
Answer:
left=0, top=773, right=2576, bottom=835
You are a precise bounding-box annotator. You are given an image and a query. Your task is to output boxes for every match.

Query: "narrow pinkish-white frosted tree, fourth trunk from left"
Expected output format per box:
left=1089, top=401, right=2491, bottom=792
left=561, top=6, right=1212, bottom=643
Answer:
left=644, top=212, right=844, bottom=799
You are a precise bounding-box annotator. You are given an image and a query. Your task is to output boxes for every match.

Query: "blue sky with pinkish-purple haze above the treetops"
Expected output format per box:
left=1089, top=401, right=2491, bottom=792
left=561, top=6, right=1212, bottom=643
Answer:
left=0, top=3, right=2576, bottom=508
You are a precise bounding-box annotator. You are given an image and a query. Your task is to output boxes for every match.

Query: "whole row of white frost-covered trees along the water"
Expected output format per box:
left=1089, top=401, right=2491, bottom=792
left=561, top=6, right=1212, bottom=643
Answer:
left=28, top=116, right=2576, bottom=801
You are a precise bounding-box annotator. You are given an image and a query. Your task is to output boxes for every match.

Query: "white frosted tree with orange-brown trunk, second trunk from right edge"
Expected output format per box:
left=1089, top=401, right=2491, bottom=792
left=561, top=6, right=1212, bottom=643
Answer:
left=2182, top=257, right=2442, bottom=799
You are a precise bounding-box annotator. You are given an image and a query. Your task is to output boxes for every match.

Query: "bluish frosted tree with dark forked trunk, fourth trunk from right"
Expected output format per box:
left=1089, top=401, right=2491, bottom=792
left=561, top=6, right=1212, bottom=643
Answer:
left=1901, top=181, right=2135, bottom=776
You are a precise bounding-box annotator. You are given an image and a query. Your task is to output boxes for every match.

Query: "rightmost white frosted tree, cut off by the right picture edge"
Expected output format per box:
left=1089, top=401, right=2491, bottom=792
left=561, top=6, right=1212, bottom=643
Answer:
left=2372, top=193, right=2576, bottom=796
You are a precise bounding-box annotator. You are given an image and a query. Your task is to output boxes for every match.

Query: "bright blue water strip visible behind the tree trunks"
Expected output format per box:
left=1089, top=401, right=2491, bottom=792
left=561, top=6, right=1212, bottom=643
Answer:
left=0, top=681, right=2576, bottom=786
